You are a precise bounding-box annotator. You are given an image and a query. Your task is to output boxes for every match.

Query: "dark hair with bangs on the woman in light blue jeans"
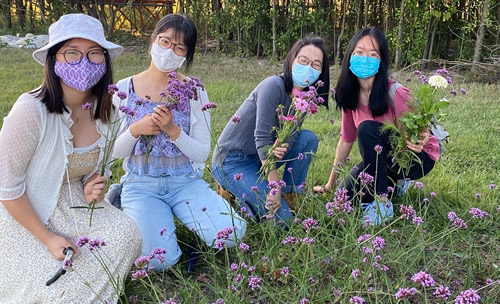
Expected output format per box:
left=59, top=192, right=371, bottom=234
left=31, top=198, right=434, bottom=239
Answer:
left=149, top=14, right=198, bottom=70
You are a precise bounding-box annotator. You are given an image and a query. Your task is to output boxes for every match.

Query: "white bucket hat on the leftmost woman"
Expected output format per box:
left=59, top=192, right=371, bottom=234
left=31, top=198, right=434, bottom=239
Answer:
left=33, top=14, right=123, bottom=65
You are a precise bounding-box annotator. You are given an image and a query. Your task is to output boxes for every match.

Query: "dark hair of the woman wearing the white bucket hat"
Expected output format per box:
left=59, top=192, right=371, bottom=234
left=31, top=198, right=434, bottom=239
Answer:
left=30, top=40, right=113, bottom=123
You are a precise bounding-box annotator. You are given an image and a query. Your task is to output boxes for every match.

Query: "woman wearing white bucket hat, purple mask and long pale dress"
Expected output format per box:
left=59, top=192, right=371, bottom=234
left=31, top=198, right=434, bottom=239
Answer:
left=0, top=14, right=141, bottom=303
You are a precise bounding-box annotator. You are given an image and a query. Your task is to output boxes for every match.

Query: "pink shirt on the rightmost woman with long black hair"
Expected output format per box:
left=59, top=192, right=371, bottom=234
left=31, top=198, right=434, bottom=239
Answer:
left=340, top=79, right=439, bottom=160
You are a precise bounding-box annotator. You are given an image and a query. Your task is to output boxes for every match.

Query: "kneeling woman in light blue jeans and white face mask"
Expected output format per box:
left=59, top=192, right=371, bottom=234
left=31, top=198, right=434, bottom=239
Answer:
left=113, top=14, right=246, bottom=270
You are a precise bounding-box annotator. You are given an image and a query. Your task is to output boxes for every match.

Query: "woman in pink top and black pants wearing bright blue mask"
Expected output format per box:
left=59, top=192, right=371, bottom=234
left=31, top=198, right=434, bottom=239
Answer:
left=313, top=28, right=439, bottom=224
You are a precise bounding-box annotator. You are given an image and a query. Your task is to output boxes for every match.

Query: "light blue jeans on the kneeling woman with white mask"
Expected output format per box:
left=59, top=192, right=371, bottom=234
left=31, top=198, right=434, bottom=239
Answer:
left=121, top=173, right=246, bottom=270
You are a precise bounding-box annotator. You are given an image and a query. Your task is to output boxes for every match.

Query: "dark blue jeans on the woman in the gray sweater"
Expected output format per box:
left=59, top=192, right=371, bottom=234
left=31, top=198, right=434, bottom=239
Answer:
left=212, top=130, right=318, bottom=222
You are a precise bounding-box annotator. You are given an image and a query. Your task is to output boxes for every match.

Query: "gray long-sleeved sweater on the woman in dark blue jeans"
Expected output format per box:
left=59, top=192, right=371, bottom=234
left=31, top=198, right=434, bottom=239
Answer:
left=212, top=75, right=297, bottom=166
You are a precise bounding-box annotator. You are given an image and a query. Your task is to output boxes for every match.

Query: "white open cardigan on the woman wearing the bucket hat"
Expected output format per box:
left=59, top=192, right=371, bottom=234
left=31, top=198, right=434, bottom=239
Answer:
left=0, top=93, right=116, bottom=224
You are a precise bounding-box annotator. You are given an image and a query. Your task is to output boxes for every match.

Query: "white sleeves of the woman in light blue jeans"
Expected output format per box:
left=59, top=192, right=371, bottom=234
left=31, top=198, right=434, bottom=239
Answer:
left=113, top=76, right=211, bottom=172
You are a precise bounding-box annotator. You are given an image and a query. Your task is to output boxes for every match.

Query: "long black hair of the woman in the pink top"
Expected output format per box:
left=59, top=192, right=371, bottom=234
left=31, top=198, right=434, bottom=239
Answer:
left=335, top=27, right=390, bottom=116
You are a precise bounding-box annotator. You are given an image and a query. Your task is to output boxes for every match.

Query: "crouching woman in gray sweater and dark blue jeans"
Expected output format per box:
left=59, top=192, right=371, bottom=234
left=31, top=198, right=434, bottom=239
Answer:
left=212, top=37, right=330, bottom=221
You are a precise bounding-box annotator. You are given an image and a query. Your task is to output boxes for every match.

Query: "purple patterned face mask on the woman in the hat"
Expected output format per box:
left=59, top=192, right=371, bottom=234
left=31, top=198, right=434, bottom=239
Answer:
left=54, top=57, right=106, bottom=92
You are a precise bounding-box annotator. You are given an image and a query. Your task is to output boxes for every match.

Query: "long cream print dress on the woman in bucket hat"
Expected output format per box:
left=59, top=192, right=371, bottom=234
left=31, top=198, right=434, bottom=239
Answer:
left=0, top=146, right=142, bottom=304
